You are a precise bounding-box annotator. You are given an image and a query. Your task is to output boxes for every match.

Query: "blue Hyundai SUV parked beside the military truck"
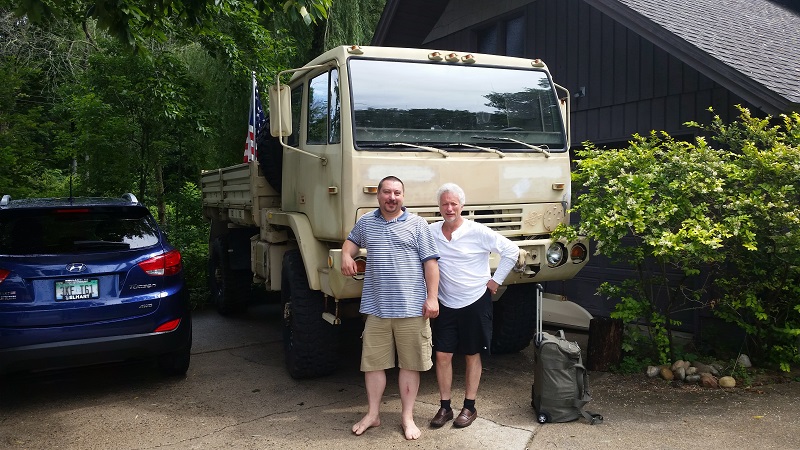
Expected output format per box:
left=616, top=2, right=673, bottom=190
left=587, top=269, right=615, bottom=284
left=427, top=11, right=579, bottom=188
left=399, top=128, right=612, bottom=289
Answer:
left=0, top=194, right=192, bottom=375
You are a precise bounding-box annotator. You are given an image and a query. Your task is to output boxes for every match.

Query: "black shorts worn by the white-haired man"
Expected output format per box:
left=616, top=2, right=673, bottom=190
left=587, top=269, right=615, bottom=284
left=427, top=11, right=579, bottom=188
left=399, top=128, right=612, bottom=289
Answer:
left=431, top=289, right=492, bottom=355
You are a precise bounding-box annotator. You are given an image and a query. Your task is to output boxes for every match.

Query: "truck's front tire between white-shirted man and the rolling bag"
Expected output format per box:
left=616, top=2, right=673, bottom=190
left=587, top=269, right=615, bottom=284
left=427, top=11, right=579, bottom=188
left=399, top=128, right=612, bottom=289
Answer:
left=492, top=283, right=536, bottom=354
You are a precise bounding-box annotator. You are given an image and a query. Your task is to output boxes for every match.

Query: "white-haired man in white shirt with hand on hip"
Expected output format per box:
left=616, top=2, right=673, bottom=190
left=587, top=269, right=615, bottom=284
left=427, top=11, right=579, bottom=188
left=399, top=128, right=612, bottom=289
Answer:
left=429, top=183, right=519, bottom=428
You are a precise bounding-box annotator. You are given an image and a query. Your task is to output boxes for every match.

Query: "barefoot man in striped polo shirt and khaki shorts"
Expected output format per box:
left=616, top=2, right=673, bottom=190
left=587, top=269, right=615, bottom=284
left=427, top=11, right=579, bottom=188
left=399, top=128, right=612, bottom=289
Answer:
left=342, top=176, right=439, bottom=439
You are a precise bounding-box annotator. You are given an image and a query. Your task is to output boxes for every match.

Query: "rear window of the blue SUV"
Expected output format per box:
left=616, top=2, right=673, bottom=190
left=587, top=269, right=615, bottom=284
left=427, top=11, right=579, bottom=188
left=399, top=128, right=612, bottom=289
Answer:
left=0, top=206, right=159, bottom=255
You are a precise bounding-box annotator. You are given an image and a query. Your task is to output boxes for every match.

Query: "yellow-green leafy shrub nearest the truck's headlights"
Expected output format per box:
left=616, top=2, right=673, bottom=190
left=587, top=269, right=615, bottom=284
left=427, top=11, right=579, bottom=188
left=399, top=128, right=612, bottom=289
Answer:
left=556, top=128, right=735, bottom=362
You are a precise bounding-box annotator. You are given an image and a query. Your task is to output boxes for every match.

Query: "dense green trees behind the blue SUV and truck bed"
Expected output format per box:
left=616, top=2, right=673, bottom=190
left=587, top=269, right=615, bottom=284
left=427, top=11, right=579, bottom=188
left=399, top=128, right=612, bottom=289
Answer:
left=0, top=0, right=385, bottom=306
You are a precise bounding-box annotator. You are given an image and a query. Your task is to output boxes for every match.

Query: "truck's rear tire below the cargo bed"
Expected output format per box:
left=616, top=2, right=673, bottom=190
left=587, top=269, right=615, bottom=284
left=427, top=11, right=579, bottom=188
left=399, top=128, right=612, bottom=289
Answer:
left=208, top=236, right=253, bottom=316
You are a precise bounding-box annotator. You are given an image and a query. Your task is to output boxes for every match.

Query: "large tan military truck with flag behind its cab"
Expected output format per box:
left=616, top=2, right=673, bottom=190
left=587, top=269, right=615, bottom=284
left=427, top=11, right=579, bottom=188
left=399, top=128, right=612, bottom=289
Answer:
left=201, top=46, right=591, bottom=378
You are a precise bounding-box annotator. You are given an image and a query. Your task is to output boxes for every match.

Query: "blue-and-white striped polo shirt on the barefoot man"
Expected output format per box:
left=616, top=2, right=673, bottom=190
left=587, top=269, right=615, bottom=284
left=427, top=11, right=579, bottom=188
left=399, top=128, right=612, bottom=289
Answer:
left=347, top=207, right=439, bottom=318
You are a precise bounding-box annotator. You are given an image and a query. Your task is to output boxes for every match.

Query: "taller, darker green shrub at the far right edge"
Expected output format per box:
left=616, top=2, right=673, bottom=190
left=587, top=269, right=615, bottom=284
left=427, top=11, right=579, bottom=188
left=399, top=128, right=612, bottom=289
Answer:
left=692, top=109, right=800, bottom=371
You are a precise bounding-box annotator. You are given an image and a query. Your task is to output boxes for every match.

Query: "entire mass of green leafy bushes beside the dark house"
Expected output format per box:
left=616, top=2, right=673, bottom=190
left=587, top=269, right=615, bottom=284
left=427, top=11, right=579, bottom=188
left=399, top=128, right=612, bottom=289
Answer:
left=557, top=109, right=800, bottom=371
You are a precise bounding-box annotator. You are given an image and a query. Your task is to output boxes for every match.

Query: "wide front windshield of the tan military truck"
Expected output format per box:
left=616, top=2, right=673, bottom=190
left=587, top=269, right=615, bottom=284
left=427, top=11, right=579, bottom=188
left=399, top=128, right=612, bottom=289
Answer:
left=349, top=58, right=566, bottom=153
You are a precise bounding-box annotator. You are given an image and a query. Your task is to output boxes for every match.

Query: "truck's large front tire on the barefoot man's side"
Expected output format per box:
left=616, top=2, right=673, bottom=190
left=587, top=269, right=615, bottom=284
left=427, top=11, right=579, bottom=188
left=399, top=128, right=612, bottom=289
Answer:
left=281, top=249, right=338, bottom=379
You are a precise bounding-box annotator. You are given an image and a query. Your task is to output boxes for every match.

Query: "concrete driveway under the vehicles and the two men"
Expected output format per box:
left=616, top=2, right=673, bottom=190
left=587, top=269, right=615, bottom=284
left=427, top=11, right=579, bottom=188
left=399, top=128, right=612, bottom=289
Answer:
left=0, top=304, right=800, bottom=450
